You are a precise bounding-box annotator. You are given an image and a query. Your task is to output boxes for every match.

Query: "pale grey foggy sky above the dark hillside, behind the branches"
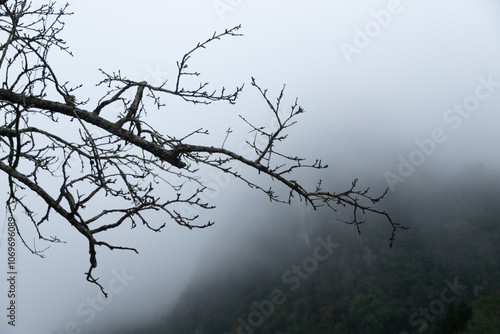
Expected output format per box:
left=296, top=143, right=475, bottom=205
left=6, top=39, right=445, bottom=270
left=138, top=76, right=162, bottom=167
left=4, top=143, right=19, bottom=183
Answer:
left=0, top=0, right=500, bottom=334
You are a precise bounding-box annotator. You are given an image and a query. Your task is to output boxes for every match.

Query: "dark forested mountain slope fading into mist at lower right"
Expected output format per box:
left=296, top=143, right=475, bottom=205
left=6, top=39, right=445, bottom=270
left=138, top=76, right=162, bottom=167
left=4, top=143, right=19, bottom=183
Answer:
left=115, top=165, right=500, bottom=334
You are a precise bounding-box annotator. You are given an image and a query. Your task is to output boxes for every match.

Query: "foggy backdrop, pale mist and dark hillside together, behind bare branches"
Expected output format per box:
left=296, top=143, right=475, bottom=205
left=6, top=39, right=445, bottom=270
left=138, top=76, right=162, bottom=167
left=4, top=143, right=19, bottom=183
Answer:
left=0, top=0, right=500, bottom=334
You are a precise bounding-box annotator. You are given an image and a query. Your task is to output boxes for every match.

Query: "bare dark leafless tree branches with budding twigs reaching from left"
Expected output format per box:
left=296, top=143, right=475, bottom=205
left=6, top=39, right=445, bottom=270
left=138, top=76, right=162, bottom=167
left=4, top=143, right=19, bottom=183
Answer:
left=0, top=0, right=406, bottom=294
